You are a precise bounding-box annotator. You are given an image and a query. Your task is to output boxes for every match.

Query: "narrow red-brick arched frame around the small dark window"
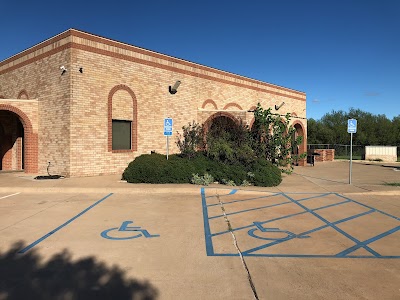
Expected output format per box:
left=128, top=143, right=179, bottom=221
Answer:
left=108, top=84, right=137, bottom=153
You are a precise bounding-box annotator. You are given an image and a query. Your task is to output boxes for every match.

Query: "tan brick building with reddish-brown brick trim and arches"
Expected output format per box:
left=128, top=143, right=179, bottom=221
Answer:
left=0, top=29, right=307, bottom=176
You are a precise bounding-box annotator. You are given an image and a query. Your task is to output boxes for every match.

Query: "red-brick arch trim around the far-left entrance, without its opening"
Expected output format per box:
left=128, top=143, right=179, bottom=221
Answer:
left=0, top=104, right=39, bottom=173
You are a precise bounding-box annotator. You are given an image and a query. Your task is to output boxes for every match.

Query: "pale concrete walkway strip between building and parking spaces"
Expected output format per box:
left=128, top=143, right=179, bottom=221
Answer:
left=0, top=161, right=400, bottom=195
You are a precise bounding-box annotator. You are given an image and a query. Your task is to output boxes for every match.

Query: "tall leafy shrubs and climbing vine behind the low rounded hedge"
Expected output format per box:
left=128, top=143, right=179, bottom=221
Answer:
left=177, top=104, right=306, bottom=173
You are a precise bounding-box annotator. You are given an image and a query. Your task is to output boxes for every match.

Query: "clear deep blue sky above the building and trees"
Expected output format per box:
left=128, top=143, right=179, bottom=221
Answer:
left=0, top=0, right=400, bottom=119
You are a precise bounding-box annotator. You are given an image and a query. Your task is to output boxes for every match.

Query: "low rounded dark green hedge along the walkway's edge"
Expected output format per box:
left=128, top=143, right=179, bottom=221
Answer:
left=122, top=152, right=282, bottom=186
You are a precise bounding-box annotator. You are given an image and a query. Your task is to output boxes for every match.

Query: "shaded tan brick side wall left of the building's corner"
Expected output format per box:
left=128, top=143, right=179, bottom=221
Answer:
left=0, top=43, right=71, bottom=175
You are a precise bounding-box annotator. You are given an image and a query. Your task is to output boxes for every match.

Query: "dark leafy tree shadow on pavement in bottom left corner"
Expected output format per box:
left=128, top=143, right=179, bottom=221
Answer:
left=0, top=242, right=158, bottom=300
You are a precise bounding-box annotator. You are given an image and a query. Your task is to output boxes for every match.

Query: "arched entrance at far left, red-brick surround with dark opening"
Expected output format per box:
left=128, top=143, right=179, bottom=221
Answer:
left=0, top=104, right=38, bottom=173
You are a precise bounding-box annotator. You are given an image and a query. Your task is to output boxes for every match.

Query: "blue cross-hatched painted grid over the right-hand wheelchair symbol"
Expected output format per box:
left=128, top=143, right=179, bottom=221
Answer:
left=201, top=188, right=400, bottom=258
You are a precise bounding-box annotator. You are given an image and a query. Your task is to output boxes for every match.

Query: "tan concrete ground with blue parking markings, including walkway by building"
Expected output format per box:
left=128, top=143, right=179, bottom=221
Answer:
left=0, top=163, right=400, bottom=299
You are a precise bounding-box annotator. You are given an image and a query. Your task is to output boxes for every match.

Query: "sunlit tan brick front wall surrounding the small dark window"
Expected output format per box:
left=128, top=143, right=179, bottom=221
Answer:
left=71, top=45, right=306, bottom=176
